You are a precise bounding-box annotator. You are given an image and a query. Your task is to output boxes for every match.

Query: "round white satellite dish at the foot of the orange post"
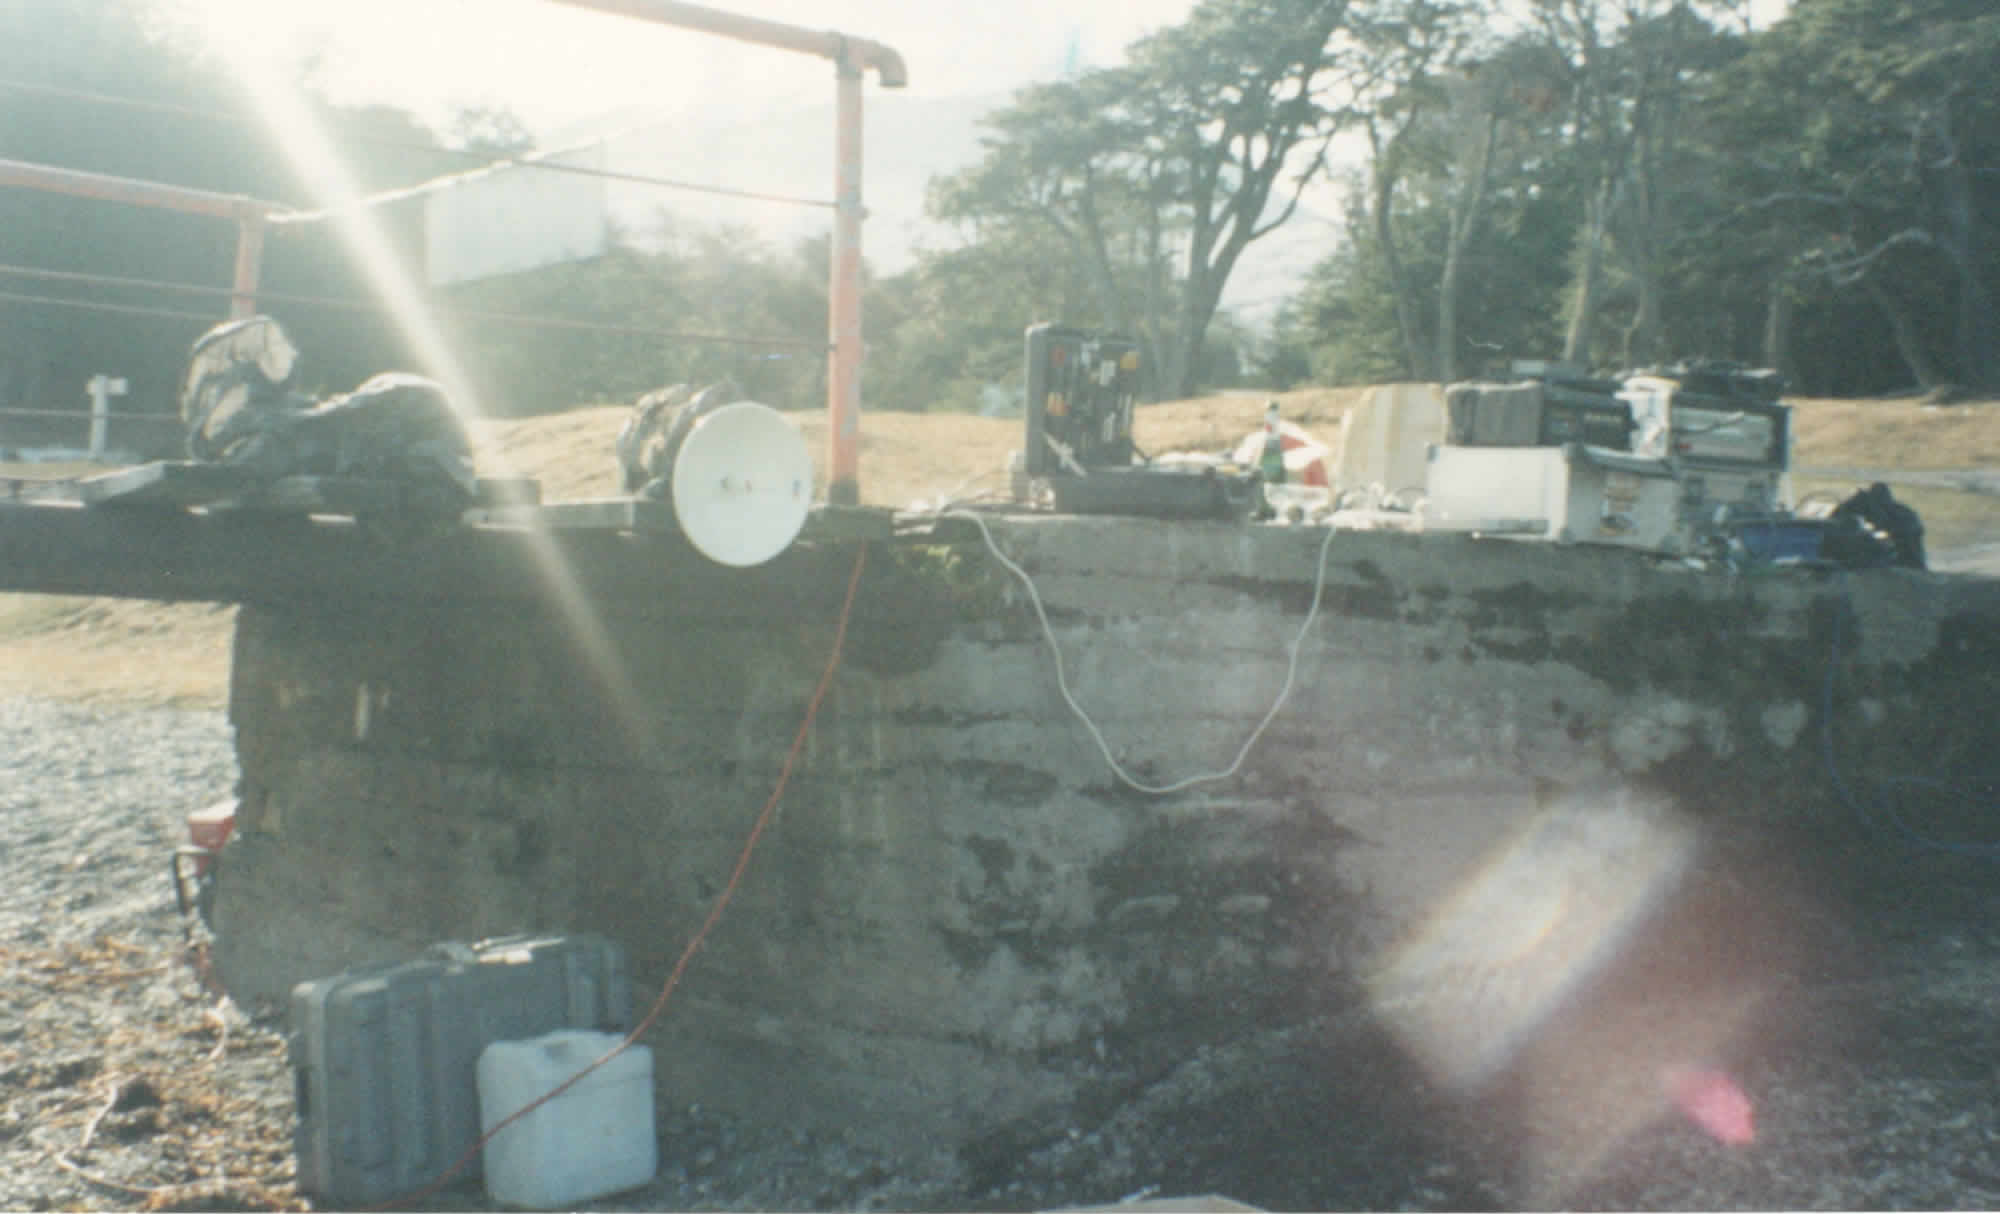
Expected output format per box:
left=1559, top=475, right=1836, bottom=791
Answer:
left=672, top=400, right=812, bottom=568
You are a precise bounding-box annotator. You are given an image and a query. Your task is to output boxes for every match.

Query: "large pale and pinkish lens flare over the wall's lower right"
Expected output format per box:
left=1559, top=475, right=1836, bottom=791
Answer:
left=1370, top=790, right=1784, bottom=1206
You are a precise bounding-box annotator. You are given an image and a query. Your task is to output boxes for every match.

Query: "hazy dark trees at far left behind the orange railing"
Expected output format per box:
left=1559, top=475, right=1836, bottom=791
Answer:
left=0, top=0, right=498, bottom=434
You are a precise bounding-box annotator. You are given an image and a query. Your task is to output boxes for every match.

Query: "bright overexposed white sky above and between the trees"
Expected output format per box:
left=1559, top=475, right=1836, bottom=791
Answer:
left=166, top=0, right=1786, bottom=320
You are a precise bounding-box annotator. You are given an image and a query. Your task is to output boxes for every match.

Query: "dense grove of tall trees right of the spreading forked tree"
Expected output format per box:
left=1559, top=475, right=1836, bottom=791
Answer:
left=1274, top=0, right=2000, bottom=394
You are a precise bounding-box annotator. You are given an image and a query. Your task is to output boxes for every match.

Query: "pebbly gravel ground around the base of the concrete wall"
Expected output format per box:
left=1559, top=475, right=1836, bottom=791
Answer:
left=0, top=698, right=2000, bottom=1210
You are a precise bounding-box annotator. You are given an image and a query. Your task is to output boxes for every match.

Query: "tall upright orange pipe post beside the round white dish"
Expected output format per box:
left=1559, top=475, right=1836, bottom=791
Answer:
left=826, top=48, right=864, bottom=506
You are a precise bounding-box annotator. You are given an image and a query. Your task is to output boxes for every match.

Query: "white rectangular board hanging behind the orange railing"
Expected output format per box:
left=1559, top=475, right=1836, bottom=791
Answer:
left=424, top=144, right=610, bottom=286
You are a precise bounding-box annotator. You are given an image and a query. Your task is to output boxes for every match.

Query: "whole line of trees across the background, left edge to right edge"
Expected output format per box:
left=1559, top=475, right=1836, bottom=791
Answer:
left=0, top=0, right=2000, bottom=442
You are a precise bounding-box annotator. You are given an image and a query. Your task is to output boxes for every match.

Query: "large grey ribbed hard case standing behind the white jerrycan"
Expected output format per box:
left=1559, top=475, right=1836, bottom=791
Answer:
left=290, top=934, right=632, bottom=1208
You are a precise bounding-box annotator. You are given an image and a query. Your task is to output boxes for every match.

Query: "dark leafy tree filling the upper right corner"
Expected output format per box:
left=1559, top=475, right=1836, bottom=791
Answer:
left=1718, top=0, right=2000, bottom=392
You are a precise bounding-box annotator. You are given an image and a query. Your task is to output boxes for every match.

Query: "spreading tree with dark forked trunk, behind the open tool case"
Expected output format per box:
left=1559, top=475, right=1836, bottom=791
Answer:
left=932, top=0, right=1346, bottom=396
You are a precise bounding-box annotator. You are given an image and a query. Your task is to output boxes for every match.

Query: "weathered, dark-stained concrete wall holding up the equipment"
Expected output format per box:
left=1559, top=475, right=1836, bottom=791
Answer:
left=216, top=518, right=2000, bottom=1142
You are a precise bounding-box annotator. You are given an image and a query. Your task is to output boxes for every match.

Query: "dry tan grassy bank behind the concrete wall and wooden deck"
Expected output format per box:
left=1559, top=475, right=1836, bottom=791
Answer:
left=0, top=388, right=2000, bottom=706
